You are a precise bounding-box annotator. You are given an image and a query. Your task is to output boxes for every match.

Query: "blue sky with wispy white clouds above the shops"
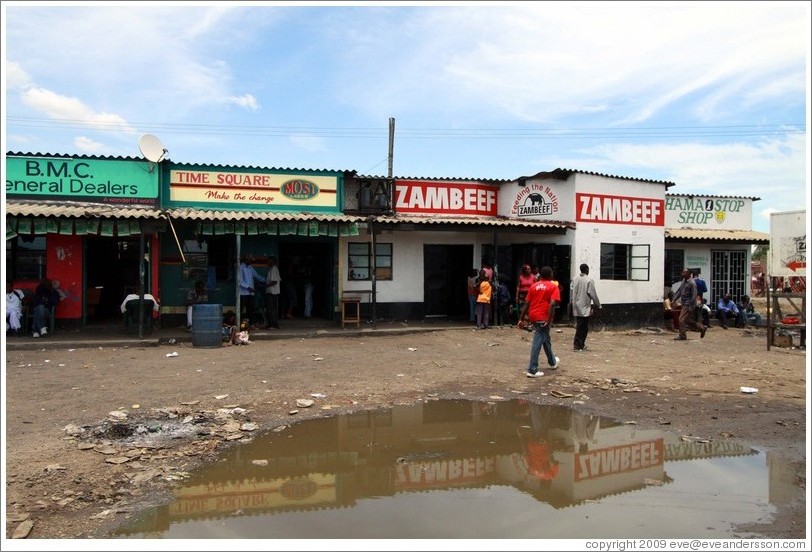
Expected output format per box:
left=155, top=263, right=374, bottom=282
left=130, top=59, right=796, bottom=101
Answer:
left=2, top=1, right=810, bottom=232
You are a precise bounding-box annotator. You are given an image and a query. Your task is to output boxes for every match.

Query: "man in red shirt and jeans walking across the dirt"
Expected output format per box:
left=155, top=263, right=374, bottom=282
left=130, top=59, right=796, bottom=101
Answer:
left=519, top=266, right=561, bottom=378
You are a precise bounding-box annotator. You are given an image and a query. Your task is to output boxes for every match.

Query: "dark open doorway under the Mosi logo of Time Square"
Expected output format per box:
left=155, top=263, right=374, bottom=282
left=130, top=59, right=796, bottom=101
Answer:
left=279, top=240, right=337, bottom=320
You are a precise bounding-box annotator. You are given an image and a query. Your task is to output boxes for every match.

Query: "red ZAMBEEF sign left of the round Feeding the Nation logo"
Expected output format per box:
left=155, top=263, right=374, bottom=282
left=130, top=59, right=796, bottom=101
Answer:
left=395, top=180, right=497, bottom=216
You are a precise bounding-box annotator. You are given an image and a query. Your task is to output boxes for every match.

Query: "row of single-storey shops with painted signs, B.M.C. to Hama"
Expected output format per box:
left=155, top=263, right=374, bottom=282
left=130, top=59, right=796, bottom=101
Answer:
left=4, top=153, right=769, bottom=327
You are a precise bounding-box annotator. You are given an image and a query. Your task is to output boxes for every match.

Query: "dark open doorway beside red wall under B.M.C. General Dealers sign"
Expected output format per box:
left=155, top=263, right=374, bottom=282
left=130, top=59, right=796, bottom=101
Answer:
left=85, top=236, right=150, bottom=324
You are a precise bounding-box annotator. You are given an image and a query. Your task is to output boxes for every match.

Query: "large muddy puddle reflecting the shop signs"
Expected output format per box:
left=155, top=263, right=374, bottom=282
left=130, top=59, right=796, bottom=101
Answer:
left=114, top=400, right=778, bottom=539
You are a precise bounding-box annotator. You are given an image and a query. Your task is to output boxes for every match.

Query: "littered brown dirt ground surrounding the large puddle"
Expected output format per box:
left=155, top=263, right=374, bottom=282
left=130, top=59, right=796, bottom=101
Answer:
left=4, top=306, right=809, bottom=548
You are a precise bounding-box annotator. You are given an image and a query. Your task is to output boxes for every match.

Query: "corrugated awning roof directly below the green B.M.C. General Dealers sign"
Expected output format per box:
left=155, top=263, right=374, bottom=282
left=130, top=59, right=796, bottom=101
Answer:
left=4, top=200, right=163, bottom=219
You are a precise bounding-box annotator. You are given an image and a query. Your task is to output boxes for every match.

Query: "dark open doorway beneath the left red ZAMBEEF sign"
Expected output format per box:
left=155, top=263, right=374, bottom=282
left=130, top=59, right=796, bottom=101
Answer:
left=423, top=245, right=478, bottom=320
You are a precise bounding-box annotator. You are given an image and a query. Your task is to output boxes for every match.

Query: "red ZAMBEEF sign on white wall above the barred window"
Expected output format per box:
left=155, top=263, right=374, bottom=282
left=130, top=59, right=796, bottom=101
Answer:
left=575, top=194, right=665, bottom=226
